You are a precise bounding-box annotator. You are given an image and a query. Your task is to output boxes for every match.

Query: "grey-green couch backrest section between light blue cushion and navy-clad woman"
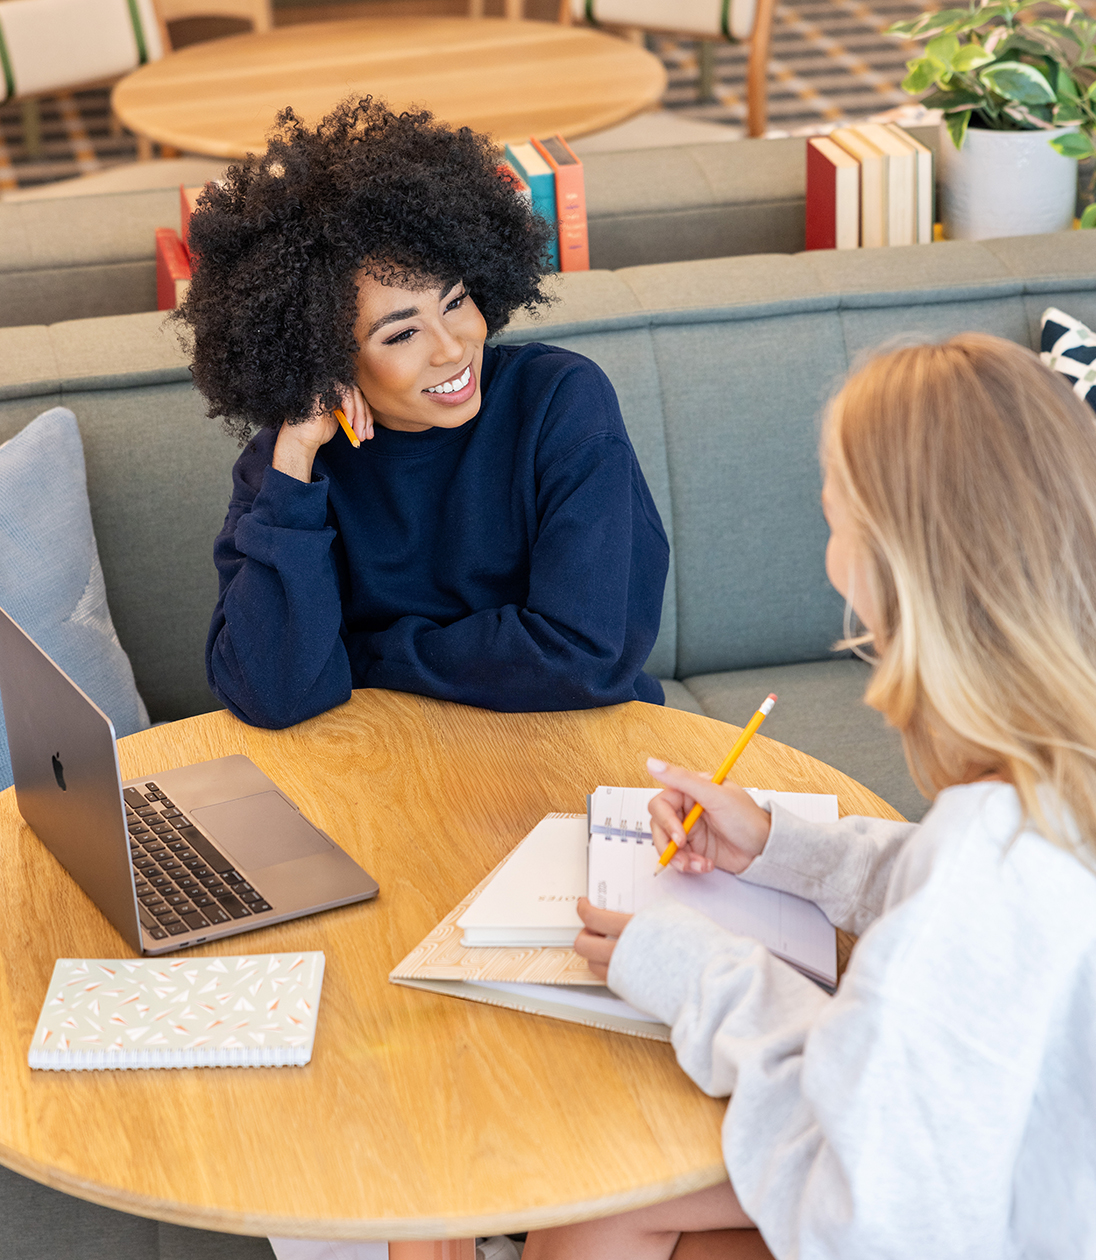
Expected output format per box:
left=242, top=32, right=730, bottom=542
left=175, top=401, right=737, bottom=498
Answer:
left=0, top=311, right=239, bottom=721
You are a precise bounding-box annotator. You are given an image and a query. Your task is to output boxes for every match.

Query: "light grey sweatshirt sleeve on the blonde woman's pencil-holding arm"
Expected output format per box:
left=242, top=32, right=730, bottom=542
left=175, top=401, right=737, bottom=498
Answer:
left=738, top=805, right=918, bottom=936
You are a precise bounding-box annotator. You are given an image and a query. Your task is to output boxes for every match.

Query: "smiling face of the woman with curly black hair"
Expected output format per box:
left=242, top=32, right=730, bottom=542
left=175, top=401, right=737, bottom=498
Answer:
left=354, top=271, right=488, bottom=433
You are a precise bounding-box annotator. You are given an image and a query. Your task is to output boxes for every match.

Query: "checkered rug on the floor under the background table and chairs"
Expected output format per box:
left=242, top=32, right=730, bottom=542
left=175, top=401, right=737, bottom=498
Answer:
left=0, top=0, right=923, bottom=190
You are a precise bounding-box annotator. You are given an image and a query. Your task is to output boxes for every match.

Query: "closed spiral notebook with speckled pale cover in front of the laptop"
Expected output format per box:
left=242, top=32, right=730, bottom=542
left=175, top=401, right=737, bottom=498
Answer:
left=26, top=953, right=324, bottom=1071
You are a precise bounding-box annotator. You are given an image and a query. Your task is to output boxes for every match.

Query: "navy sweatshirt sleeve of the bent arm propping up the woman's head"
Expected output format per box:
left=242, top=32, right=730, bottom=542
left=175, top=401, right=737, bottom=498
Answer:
left=205, top=451, right=350, bottom=728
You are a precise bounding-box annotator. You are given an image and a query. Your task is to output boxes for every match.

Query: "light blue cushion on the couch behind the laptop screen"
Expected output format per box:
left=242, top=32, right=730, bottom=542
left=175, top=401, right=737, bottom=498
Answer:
left=0, top=407, right=149, bottom=789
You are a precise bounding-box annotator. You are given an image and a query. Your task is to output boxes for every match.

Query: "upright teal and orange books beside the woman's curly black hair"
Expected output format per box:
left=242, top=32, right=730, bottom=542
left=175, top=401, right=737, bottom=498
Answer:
left=503, top=135, right=590, bottom=271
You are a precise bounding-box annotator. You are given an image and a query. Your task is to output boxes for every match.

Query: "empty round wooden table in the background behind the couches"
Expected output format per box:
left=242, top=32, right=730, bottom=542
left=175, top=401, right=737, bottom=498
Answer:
left=112, top=18, right=666, bottom=158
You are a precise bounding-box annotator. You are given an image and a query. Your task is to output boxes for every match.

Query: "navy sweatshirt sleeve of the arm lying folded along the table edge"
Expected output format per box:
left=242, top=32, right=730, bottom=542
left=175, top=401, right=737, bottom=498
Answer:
left=350, top=372, right=669, bottom=712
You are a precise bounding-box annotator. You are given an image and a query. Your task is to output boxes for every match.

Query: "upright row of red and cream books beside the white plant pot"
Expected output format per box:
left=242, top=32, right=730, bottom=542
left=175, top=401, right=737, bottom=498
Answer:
left=806, top=122, right=936, bottom=249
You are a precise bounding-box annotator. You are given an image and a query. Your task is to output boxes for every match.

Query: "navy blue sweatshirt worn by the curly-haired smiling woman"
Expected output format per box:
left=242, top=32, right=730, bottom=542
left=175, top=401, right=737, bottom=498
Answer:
left=207, top=345, right=669, bottom=727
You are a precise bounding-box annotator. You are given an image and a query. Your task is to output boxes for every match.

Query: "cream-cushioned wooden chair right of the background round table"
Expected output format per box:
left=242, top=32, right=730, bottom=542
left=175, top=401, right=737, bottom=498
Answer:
left=559, top=0, right=776, bottom=136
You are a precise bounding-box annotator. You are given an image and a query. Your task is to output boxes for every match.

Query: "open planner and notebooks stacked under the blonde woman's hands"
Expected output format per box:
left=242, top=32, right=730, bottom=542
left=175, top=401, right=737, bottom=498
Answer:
left=389, top=788, right=838, bottom=1041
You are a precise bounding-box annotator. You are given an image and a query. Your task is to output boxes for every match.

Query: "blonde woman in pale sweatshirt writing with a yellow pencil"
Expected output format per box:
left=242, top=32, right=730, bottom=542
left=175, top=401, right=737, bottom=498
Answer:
left=525, top=334, right=1096, bottom=1260
